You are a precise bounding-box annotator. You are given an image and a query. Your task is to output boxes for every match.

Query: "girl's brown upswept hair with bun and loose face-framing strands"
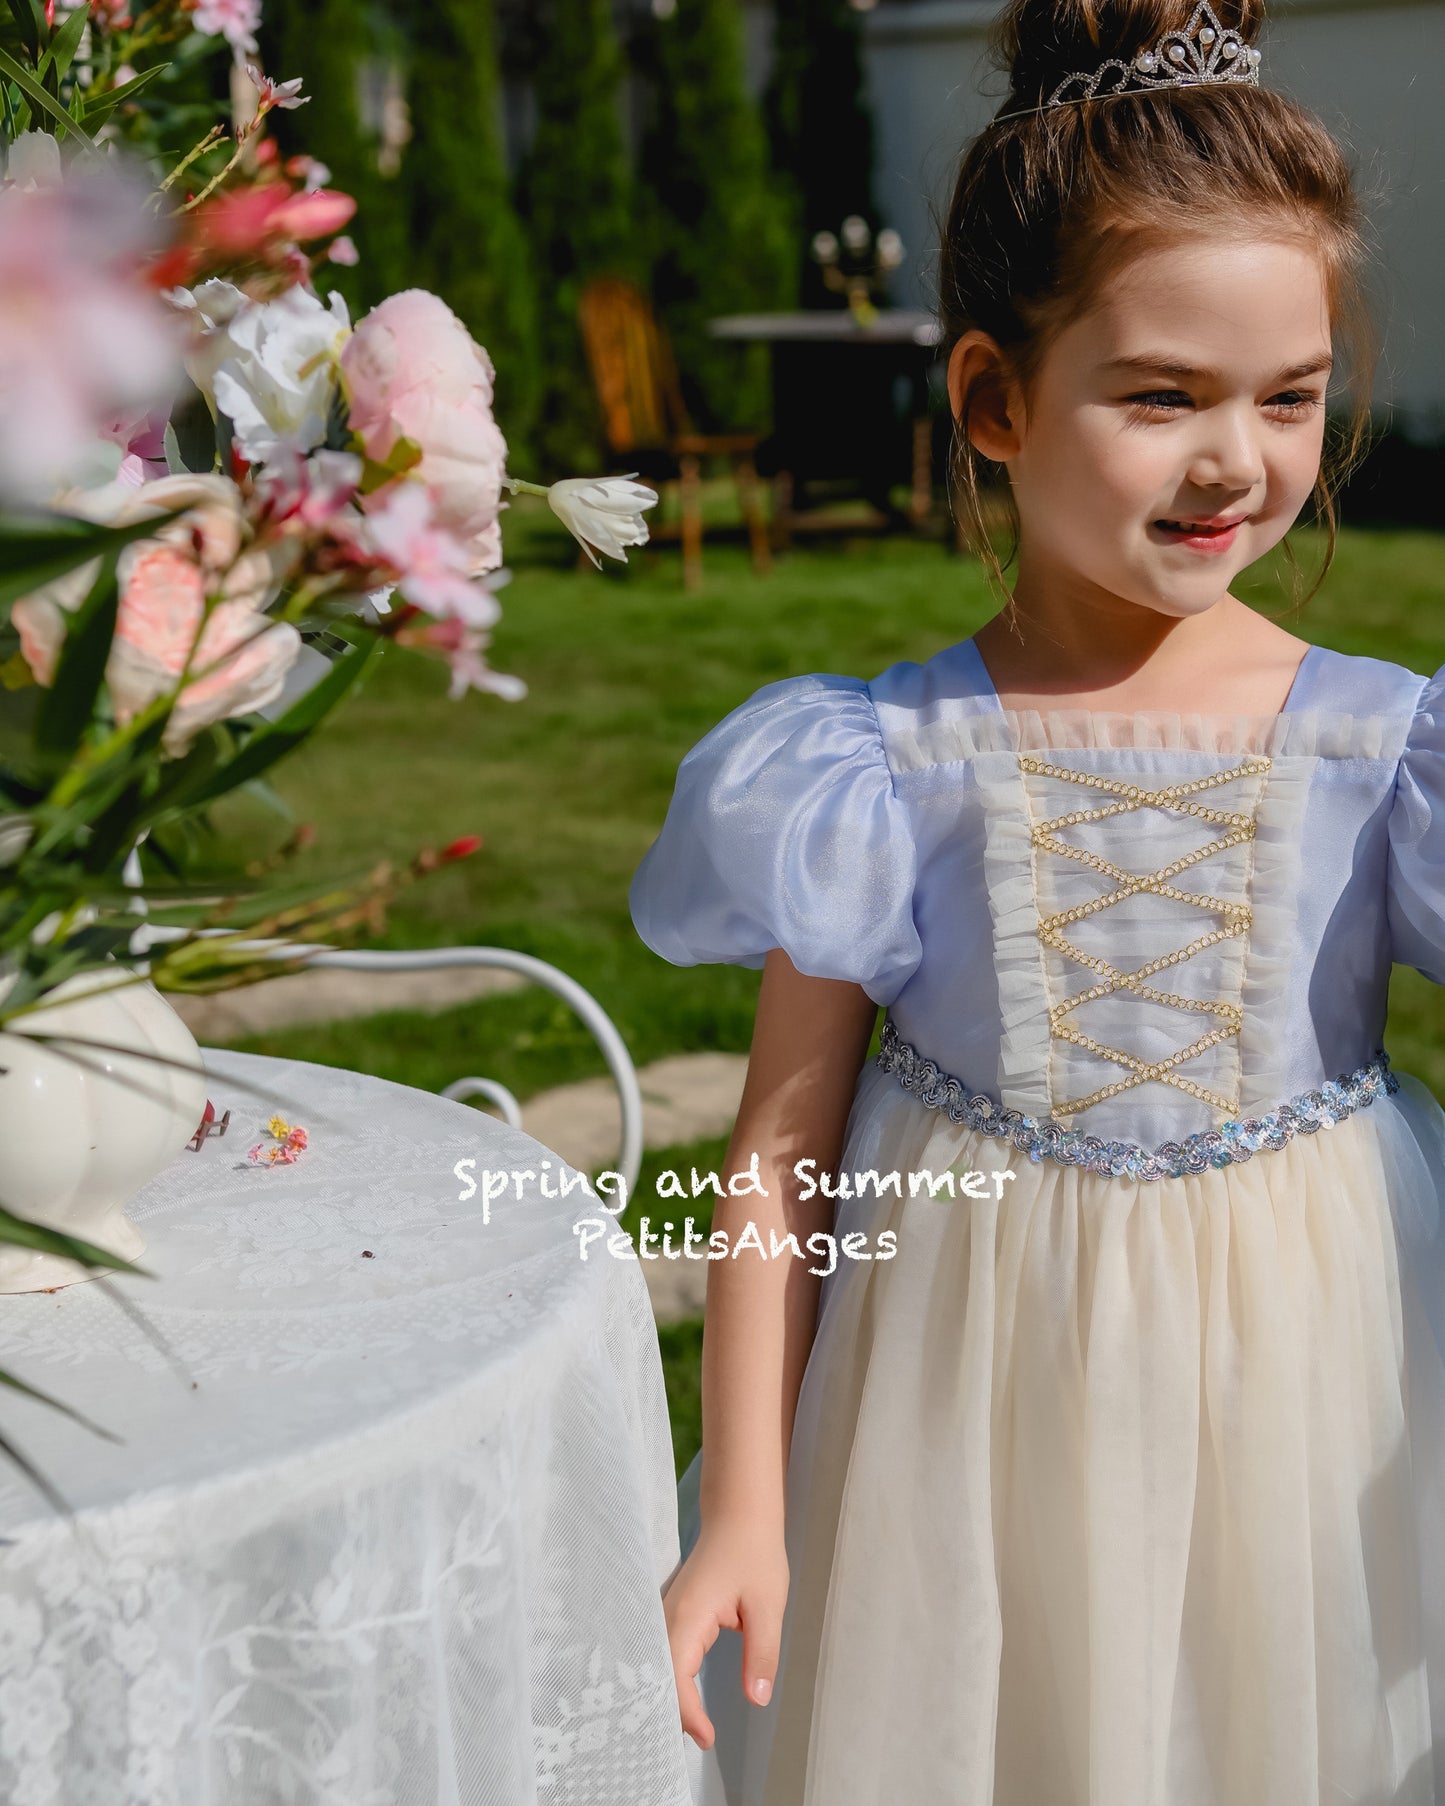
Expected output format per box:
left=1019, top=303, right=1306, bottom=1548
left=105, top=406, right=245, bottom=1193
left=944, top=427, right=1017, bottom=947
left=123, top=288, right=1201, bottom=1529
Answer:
left=939, top=0, right=1376, bottom=607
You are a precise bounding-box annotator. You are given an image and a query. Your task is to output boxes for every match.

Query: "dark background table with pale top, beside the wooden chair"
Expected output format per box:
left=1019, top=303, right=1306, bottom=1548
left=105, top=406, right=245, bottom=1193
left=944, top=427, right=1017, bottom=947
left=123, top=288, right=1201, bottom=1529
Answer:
left=708, top=307, right=939, bottom=524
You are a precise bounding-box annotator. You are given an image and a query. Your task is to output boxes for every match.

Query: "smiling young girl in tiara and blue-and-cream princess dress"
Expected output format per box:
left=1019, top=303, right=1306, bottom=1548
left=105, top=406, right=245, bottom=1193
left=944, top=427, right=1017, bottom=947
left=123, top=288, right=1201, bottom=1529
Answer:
left=632, top=0, right=1445, bottom=1806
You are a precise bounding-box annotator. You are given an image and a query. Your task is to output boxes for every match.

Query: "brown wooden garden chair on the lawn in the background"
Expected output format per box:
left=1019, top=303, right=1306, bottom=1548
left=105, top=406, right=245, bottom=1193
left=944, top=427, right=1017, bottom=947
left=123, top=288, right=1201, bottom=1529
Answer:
left=578, top=276, right=773, bottom=591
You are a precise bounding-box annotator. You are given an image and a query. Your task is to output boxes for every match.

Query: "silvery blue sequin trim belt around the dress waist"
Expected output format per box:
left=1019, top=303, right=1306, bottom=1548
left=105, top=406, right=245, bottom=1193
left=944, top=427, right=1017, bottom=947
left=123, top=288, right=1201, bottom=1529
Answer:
left=878, top=1017, right=1400, bottom=1179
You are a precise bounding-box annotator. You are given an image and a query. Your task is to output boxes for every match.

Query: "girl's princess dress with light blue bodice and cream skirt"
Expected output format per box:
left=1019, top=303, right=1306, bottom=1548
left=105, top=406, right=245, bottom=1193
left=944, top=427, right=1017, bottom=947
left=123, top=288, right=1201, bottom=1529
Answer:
left=630, top=639, right=1445, bottom=1806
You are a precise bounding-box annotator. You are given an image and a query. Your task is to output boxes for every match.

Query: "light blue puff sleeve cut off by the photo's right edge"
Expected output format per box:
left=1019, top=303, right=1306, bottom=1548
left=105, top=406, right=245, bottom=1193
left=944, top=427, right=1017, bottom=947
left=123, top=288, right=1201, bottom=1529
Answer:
left=1389, top=666, right=1445, bottom=984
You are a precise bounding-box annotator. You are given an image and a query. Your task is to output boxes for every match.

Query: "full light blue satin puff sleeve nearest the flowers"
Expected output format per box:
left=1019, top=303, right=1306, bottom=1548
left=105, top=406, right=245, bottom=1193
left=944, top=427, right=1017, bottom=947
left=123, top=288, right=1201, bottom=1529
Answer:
left=629, top=675, right=923, bottom=1004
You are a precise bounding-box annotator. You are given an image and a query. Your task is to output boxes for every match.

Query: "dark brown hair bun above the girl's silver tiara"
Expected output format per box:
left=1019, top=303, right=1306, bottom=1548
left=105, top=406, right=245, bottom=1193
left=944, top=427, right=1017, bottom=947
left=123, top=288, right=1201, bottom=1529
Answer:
left=993, top=0, right=1264, bottom=110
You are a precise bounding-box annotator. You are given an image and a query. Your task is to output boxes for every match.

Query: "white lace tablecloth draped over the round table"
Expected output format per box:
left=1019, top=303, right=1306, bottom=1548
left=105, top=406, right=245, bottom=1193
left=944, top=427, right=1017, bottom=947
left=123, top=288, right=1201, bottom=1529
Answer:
left=0, top=1051, right=688, bottom=1806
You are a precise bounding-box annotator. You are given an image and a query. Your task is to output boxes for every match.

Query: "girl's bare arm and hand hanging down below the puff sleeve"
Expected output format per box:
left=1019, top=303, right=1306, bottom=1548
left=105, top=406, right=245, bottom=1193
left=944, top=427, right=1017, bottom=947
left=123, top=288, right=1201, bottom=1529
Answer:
left=663, top=948, right=878, bottom=1748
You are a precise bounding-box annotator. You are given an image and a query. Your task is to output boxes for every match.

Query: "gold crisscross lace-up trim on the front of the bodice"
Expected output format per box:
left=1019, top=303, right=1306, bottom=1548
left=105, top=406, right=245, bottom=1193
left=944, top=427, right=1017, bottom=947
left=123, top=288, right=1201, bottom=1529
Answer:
left=1019, top=753, right=1270, bottom=1116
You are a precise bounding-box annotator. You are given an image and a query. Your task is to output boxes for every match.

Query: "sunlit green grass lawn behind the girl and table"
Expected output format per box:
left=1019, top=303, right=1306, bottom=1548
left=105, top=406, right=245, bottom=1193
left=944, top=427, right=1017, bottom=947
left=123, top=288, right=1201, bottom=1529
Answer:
left=217, top=486, right=1445, bottom=1472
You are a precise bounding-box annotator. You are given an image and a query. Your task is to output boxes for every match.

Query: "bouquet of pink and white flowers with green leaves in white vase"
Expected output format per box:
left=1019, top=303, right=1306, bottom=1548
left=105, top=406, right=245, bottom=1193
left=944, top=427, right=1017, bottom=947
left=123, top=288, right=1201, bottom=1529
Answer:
left=0, top=17, right=656, bottom=1466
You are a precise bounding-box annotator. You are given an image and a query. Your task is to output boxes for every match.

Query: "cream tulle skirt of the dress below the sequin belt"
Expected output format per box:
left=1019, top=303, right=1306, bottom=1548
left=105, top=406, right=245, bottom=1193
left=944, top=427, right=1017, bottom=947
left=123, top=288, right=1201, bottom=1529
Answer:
left=679, top=1067, right=1445, bottom=1806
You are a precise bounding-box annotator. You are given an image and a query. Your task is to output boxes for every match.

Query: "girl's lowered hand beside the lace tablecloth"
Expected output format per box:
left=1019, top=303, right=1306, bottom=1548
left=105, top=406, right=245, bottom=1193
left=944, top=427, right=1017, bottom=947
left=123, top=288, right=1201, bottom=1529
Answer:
left=663, top=1522, right=788, bottom=1750
